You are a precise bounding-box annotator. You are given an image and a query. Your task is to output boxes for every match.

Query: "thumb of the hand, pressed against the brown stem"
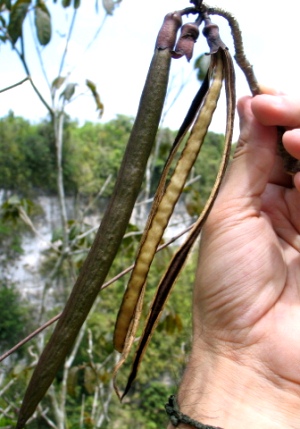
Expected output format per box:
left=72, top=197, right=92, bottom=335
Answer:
left=218, top=97, right=277, bottom=210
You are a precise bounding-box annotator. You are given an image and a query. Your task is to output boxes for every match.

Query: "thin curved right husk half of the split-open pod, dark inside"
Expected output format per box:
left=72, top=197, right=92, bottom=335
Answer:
left=123, top=50, right=236, bottom=396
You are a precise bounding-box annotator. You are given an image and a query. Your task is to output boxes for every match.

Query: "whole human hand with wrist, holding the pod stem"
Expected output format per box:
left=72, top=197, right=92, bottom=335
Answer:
left=171, top=95, right=300, bottom=429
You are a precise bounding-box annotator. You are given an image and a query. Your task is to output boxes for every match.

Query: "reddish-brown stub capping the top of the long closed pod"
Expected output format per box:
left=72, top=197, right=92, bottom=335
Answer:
left=155, top=12, right=182, bottom=51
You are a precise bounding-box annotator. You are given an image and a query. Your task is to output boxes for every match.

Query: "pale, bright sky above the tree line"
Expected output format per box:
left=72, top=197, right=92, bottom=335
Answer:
left=0, top=0, right=300, bottom=137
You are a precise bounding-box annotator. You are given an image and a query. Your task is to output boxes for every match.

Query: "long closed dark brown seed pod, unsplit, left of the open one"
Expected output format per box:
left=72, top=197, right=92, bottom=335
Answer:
left=16, top=15, right=181, bottom=429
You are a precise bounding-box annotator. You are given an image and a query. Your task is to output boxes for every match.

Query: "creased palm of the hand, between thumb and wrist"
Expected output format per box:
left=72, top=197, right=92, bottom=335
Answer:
left=194, top=94, right=300, bottom=383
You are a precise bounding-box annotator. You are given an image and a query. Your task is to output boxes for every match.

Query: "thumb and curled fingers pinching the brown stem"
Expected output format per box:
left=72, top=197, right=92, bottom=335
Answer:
left=212, top=90, right=300, bottom=216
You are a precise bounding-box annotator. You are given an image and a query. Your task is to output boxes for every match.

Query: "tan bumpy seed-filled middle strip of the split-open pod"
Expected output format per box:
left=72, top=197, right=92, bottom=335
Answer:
left=114, top=49, right=223, bottom=394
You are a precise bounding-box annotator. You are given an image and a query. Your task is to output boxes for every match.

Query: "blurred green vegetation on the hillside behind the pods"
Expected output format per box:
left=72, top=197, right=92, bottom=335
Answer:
left=0, top=112, right=227, bottom=429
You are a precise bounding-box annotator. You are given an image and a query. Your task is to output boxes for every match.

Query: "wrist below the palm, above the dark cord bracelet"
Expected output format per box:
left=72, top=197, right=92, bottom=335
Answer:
left=168, top=350, right=300, bottom=429
